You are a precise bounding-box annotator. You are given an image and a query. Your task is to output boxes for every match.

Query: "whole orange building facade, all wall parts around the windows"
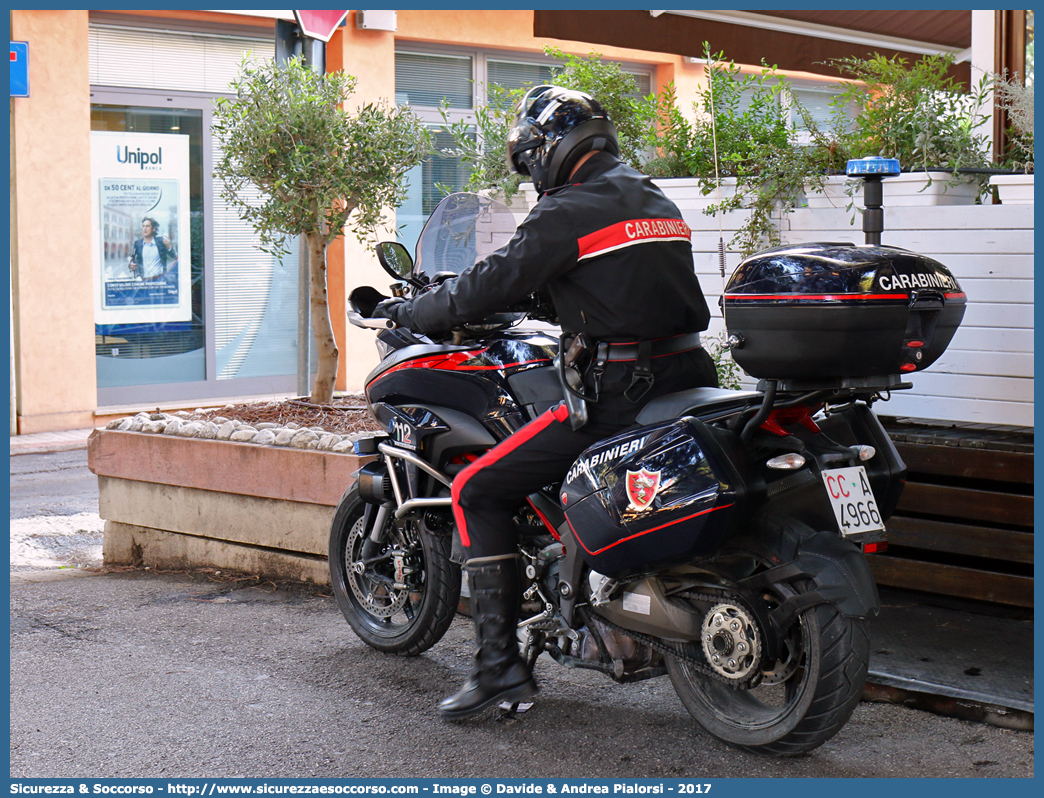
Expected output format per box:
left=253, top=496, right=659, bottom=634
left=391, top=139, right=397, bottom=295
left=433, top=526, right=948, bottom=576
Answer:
left=11, top=10, right=734, bottom=432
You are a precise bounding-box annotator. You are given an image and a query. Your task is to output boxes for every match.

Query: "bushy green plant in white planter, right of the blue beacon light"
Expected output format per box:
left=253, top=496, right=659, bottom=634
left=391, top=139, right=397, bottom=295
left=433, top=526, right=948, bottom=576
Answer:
left=831, top=54, right=992, bottom=206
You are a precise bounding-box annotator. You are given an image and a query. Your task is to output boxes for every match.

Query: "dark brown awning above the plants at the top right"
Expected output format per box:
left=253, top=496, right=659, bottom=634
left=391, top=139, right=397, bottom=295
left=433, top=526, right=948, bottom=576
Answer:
left=533, top=10, right=972, bottom=83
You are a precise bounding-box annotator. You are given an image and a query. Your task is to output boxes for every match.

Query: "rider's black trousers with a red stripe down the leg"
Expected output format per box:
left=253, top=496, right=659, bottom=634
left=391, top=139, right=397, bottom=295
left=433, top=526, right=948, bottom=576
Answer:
left=452, top=349, right=717, bottom=559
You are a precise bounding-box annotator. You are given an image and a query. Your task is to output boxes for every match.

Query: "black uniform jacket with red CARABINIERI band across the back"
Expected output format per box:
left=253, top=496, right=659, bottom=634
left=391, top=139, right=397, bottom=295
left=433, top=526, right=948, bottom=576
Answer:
left=403, top=152, right=710, bottom=341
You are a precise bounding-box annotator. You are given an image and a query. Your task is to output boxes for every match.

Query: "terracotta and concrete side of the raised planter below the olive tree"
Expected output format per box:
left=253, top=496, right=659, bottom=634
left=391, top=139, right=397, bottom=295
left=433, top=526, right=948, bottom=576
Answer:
left=88, top=429, right=366, bottom=584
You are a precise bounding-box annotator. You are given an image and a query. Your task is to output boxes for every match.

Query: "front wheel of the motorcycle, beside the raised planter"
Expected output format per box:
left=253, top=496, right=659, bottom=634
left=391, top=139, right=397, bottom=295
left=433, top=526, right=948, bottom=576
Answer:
left=330, top=487, right=460, bottom=656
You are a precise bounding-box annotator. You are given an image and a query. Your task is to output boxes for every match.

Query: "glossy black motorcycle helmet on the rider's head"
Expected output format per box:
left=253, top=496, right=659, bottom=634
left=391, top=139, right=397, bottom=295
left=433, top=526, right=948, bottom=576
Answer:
left=507, top=86, right=620, bottom=195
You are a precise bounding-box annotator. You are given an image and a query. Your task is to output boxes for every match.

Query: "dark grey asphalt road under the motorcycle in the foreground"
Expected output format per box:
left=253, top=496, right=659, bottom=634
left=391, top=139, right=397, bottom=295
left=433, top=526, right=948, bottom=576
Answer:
left=10, top=571, right=1034, bottom=778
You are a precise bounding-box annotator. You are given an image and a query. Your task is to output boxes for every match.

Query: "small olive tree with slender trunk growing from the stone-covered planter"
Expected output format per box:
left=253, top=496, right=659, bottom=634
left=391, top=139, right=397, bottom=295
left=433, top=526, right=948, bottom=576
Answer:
left=213, top=57, right=431, bottom=403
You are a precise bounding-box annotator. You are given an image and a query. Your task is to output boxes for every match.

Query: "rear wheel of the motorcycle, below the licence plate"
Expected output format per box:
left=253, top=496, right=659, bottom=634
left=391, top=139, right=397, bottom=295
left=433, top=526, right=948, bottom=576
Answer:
left=667, top=572, right=870, bottom=756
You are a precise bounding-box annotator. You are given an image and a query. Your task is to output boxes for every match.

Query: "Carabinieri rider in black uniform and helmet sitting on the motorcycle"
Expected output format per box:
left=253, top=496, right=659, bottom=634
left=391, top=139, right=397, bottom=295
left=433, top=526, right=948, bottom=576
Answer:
left=374, top=86, right=717, bottom=719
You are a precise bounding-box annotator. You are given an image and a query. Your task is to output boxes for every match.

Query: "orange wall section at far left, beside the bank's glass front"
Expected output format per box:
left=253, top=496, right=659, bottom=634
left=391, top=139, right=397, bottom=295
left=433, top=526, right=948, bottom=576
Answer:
left=11, top=10, right=97, bottom=433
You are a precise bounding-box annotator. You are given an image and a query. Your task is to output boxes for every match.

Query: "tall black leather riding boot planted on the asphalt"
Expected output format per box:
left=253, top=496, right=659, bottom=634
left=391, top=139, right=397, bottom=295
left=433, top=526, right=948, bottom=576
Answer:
left=438, top=557, right=538, bottom=720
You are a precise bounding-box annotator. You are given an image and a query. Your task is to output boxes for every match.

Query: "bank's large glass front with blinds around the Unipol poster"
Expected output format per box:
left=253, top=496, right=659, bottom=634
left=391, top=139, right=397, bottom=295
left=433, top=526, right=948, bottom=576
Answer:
left=90, top=23, right=315, bottom=406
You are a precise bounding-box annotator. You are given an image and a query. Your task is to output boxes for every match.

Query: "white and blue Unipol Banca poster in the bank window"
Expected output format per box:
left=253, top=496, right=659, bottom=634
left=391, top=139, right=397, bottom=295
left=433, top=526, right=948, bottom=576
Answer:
left=91, top=131, right=192, bottom=324
